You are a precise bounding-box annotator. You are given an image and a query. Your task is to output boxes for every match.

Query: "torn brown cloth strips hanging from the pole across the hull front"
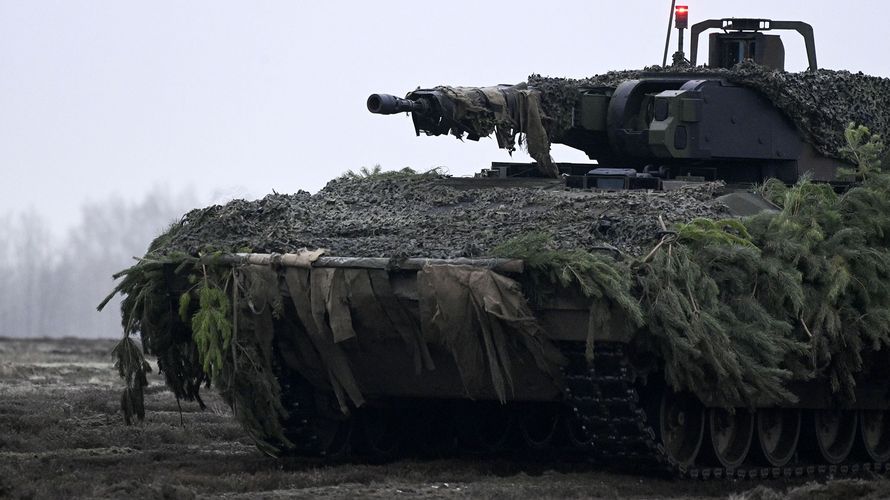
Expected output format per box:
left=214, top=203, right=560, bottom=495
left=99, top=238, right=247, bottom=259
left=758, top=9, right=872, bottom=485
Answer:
left=242, top=265, right=563, bottom=413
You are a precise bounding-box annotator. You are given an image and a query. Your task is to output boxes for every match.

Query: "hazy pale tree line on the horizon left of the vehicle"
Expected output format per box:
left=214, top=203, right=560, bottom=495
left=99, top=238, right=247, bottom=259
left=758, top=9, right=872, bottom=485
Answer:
left=0, top=187, right=196, bottom=337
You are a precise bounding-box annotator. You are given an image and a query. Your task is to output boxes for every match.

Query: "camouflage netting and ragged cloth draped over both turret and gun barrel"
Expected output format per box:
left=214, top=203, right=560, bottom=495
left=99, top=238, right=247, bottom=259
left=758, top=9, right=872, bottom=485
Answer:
left=398, top=62, right=890, bottom=177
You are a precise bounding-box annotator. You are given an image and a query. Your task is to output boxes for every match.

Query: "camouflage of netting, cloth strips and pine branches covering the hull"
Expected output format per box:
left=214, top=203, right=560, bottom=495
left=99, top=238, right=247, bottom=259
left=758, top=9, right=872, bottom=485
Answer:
left=100, top=128, right=890, bottom=451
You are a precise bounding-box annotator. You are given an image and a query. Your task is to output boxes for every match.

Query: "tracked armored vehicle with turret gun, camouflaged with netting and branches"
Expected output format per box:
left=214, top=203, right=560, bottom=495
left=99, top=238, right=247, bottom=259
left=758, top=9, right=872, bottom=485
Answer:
left=107, top=7, right=890, bottom=477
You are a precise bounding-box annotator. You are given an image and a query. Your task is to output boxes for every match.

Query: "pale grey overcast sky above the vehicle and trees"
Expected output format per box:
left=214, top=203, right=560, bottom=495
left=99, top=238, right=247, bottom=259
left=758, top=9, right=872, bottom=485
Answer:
left=0, top=0, right=890, bottom=237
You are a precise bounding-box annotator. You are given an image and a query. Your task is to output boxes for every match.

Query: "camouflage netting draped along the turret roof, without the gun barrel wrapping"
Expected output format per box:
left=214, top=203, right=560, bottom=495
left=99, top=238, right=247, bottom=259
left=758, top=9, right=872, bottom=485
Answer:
left=528, top=62, right=890, bottom=161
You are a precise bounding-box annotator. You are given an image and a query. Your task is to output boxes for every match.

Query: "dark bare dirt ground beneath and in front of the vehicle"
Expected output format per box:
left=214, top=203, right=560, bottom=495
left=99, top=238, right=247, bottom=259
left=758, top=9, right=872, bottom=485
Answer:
left=0, top=339, right=890, bottom=499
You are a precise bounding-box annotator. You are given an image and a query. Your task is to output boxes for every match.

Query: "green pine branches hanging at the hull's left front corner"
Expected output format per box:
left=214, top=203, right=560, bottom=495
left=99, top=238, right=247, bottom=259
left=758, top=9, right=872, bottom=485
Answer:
left=99, top=255, right=289, bottom=444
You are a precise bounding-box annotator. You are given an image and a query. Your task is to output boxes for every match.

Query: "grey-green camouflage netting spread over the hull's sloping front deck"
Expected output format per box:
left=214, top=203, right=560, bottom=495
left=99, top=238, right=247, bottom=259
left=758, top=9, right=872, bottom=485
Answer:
left=151, top=173, right=727, bottom=258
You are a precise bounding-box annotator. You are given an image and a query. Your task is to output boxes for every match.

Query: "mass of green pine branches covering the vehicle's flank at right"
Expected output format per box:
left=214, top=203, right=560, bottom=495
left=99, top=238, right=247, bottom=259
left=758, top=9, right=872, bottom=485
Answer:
left=499, top=125, right=890, bottom=404
